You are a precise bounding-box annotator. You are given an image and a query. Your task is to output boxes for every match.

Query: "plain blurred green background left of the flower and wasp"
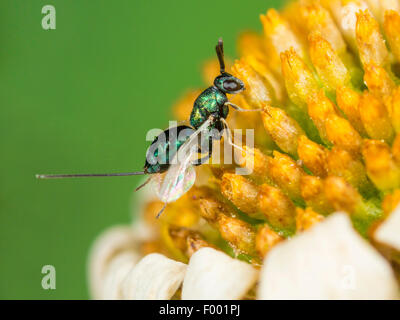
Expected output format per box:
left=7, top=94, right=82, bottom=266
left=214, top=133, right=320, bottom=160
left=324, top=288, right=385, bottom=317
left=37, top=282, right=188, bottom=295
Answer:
left=0, top=0, right=282, bottom=299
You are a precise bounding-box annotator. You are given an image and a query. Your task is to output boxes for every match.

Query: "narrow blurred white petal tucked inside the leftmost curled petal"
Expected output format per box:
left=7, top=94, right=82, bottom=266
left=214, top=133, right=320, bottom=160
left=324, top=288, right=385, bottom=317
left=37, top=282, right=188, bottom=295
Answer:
left=101, top=251, right=140, bottom=300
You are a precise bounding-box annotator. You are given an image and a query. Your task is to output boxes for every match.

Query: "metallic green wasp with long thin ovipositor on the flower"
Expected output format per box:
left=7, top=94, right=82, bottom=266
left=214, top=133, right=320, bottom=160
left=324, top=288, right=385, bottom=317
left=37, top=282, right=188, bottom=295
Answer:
left=36, top=39, right=260, bottom=217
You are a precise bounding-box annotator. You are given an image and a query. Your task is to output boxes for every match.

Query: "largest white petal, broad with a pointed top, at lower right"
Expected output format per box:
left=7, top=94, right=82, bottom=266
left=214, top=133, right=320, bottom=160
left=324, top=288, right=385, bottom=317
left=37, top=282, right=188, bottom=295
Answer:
left=258, top=213, right=399, bottom=299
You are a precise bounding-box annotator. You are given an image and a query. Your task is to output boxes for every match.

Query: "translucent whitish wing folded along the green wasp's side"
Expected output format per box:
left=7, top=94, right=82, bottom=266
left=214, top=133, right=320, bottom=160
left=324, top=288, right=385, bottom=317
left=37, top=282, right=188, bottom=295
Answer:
left=158, top=119, right=211, bottom=203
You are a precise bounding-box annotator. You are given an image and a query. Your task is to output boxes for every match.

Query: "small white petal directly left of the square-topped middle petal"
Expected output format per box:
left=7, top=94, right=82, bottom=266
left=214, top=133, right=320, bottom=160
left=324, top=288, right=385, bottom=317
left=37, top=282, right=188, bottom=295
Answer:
left=123, top=253, right=186, bottom=300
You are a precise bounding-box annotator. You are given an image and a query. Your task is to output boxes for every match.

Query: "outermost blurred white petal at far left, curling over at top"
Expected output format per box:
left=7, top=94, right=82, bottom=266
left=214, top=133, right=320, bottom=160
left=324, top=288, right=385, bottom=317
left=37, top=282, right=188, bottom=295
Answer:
left=88, top=226, right=138, bottom=299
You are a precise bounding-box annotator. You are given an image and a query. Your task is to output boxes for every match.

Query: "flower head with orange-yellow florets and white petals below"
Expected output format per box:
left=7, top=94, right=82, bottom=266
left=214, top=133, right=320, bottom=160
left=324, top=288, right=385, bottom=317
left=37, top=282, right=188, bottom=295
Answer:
left=91, top=0, right=400, bottom=299
